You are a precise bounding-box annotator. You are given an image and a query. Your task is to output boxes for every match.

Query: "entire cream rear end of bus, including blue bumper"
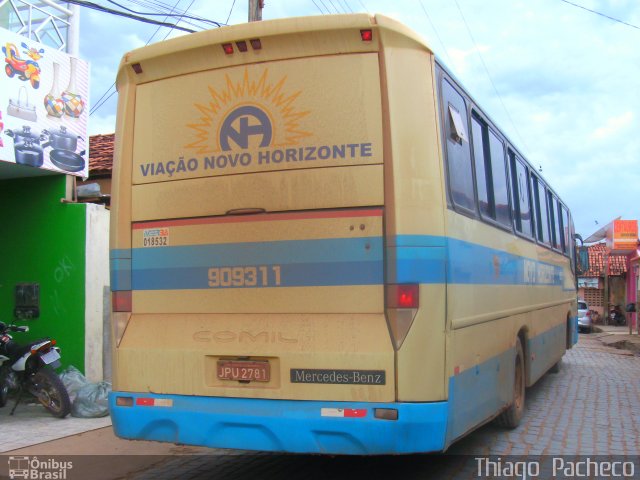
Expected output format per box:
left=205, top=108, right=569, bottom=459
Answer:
left=111, top=15, right=447, bottom=454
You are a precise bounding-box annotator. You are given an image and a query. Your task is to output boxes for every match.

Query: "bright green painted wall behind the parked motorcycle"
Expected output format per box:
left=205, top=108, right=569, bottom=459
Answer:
left=0, top=175, right=86, bottom=372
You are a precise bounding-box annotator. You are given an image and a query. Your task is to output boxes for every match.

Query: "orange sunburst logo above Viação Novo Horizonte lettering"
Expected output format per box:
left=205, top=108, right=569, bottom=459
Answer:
left=185, top=68, right=313, bottom=155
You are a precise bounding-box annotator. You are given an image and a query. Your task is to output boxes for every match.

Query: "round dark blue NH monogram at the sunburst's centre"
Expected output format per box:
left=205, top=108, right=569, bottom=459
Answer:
left=220, top=105, right=273, bottom=151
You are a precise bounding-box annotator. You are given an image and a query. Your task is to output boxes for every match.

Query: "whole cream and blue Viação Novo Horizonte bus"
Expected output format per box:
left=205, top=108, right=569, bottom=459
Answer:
left=110, top=14, right=577, bottom=455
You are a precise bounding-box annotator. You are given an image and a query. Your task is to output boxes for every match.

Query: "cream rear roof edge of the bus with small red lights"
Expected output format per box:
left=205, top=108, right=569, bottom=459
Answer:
left=117, top=13, right=431, bottom=85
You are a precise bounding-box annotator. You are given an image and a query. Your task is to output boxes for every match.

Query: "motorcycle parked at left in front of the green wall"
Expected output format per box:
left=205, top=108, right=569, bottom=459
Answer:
left=0, top=322, right=71, bottom=418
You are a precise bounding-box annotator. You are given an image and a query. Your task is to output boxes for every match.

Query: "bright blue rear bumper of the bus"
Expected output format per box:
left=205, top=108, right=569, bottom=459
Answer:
left=109, top=392, right=448, bottom=455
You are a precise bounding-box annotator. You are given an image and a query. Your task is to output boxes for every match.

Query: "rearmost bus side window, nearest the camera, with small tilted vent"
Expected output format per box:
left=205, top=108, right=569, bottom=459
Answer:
left=442, top=79, right=475, bottom=212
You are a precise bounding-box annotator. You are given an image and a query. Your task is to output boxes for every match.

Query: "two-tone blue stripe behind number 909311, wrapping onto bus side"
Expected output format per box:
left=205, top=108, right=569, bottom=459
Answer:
left=111, top=235, right=565, bottom=290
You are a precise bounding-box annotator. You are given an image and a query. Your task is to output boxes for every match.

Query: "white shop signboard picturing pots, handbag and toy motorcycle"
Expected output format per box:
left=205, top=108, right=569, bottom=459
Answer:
left=0, top=28, right=89, bottom=178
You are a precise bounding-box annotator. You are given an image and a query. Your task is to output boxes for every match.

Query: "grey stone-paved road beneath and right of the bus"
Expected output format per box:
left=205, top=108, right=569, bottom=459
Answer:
left=0, top=335, right=640, bottom=480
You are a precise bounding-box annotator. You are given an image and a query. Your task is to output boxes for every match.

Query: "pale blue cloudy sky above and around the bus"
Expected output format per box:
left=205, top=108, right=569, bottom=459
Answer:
left=80, top=0, right=640, bottom=238
